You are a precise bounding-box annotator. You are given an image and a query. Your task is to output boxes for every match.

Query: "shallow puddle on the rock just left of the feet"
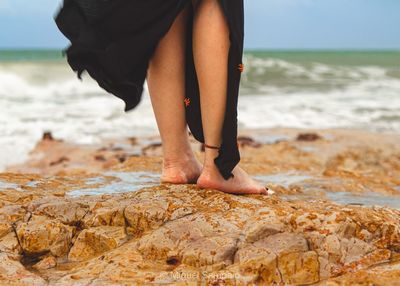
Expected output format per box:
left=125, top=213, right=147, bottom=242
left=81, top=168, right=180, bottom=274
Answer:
left=66, top=171, right=160, bottom=197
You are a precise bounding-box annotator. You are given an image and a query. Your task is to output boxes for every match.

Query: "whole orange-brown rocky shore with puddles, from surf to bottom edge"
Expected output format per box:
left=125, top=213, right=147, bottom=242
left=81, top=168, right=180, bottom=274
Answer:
left=0, top=129, right=400, bottom=285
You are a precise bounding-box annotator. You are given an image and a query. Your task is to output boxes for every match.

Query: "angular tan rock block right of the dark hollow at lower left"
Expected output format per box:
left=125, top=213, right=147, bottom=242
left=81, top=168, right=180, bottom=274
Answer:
left=68, top=226, right=127, bottom=261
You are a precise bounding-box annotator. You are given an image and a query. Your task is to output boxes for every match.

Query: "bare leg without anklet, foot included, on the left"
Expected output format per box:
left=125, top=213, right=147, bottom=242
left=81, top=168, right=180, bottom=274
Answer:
left=147, top=3, right=201, bottom=183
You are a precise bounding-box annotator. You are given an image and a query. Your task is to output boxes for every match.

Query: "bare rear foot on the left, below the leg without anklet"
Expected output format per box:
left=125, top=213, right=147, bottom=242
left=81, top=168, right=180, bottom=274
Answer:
left=161, top=155, right=202, bottom=184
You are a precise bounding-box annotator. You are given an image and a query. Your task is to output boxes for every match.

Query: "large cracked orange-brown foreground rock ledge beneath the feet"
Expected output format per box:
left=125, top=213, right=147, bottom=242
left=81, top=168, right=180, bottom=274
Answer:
left=0, top=182, right=400, bottom=285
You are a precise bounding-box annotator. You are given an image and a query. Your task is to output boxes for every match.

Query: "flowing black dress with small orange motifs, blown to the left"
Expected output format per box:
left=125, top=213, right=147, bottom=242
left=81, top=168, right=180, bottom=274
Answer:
left=55, top=0, right=244, bottom=179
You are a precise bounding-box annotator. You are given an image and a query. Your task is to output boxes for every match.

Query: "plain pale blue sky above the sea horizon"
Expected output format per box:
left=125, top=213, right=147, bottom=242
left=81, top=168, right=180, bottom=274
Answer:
left=0, top=0, right=400, bottom=50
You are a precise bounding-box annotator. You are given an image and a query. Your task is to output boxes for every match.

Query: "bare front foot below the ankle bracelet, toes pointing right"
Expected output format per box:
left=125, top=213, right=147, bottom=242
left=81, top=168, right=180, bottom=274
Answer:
left=197, top=165, right=268, bottom=194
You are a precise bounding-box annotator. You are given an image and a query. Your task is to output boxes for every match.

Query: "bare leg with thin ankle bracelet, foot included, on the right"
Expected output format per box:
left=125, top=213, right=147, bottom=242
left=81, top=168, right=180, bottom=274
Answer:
left=193, top=0, right=266, bottom=193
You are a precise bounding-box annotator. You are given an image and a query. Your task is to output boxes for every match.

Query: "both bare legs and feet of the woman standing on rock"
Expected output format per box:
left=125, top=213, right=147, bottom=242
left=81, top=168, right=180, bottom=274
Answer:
left=147, top=0, right=266, bottom=193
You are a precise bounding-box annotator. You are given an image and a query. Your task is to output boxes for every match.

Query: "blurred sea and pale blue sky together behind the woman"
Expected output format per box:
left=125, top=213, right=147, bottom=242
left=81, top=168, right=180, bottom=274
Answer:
left=0, top=0, right=400, bottom=170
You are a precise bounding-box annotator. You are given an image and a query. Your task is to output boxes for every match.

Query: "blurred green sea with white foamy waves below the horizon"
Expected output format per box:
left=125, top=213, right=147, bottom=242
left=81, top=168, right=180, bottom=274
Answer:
left=0, top=50, right=400, bottom=171
